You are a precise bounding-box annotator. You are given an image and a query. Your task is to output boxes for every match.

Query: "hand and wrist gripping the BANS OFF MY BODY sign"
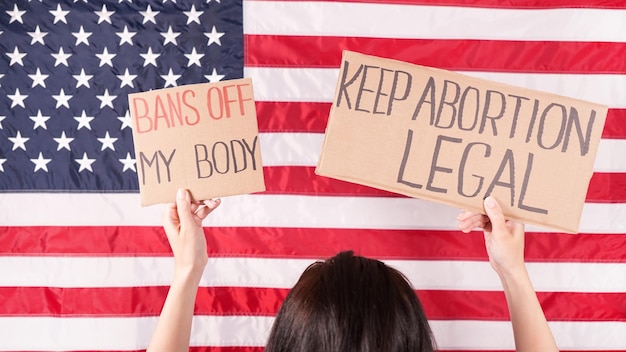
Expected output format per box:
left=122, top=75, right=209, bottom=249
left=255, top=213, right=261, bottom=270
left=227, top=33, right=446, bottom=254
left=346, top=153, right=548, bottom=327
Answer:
left=163, top=189, right=220, bottom=280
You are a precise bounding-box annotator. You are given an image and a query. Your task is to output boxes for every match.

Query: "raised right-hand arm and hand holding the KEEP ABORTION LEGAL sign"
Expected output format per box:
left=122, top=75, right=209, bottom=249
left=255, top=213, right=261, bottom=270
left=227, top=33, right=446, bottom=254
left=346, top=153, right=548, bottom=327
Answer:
left=458, top=197, right=558, bottom=352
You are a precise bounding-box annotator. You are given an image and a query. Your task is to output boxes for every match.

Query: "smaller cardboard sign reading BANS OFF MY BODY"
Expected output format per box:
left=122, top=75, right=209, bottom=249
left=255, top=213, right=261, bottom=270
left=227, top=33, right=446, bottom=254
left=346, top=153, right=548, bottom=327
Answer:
left=128, top=78, right=265, bottom=206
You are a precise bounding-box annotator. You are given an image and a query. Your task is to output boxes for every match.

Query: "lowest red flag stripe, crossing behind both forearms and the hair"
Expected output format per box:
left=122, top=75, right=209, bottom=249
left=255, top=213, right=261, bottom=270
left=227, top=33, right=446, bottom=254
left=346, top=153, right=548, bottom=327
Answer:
left=0, top=286, right=626, bottom=321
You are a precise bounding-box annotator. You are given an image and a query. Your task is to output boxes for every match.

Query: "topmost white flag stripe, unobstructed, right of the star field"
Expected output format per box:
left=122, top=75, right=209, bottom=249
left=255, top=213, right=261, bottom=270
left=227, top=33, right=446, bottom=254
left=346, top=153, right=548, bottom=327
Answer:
left=243, top=1, right=626, bottom=42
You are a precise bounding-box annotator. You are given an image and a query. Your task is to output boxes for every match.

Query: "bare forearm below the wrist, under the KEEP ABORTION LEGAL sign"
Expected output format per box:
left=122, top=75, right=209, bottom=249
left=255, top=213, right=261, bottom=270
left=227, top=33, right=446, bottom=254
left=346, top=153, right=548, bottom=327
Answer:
left=501, top=268, right=558, bottom=352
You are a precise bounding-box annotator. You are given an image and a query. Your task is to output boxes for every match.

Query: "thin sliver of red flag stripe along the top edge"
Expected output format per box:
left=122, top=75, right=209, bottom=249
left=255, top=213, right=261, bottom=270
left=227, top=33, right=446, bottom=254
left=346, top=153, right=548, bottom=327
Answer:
left=250, top=0, right=626, bottom=9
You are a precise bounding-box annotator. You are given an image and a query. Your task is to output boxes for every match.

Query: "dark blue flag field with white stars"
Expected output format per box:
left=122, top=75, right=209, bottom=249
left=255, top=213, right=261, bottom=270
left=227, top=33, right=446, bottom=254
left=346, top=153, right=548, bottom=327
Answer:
left=0, top=0, right=236, bottom=187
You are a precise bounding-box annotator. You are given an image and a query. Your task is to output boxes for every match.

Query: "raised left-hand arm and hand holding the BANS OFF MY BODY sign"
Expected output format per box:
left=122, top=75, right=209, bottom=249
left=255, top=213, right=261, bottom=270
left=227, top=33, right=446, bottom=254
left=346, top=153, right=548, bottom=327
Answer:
left=148, top=190, right=220, bottom=352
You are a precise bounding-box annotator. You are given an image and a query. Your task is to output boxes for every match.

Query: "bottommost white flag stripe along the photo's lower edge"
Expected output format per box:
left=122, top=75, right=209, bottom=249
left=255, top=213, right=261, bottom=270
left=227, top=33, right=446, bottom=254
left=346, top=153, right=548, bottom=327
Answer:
left=0, top=316, right=626, bottom=351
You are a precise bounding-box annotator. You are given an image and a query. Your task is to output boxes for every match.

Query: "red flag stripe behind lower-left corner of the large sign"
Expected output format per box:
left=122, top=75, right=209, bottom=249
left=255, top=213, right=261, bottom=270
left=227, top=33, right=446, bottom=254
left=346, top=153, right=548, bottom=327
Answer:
left=263, top=166, right=626, bottom=203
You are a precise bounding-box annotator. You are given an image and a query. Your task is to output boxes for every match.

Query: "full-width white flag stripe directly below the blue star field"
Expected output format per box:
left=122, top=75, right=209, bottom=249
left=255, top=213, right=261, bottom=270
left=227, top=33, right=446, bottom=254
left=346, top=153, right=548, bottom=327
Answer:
left=0, top=193, right=626, bottom=233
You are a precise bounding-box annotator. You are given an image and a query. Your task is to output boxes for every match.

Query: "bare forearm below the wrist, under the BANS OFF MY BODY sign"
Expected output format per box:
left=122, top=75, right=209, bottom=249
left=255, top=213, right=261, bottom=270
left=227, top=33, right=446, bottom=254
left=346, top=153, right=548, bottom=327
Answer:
left=148, top=274, right=199, bottom=352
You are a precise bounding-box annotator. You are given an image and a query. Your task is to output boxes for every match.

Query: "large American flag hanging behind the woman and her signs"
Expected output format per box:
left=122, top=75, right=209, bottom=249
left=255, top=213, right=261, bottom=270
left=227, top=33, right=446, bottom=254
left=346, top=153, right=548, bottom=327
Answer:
left=0, top=0, right=626, bottom=352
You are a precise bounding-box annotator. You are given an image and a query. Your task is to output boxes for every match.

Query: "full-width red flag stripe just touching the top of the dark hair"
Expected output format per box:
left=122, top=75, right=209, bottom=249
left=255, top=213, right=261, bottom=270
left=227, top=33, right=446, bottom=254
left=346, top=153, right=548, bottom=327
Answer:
left=0, top=226, right=626, bottom=263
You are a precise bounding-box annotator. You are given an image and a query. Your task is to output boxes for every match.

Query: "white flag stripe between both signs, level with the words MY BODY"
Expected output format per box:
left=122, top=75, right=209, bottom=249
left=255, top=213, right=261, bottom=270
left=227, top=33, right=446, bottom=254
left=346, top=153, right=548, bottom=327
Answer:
left=260, top=133, right=626, bottom=172
